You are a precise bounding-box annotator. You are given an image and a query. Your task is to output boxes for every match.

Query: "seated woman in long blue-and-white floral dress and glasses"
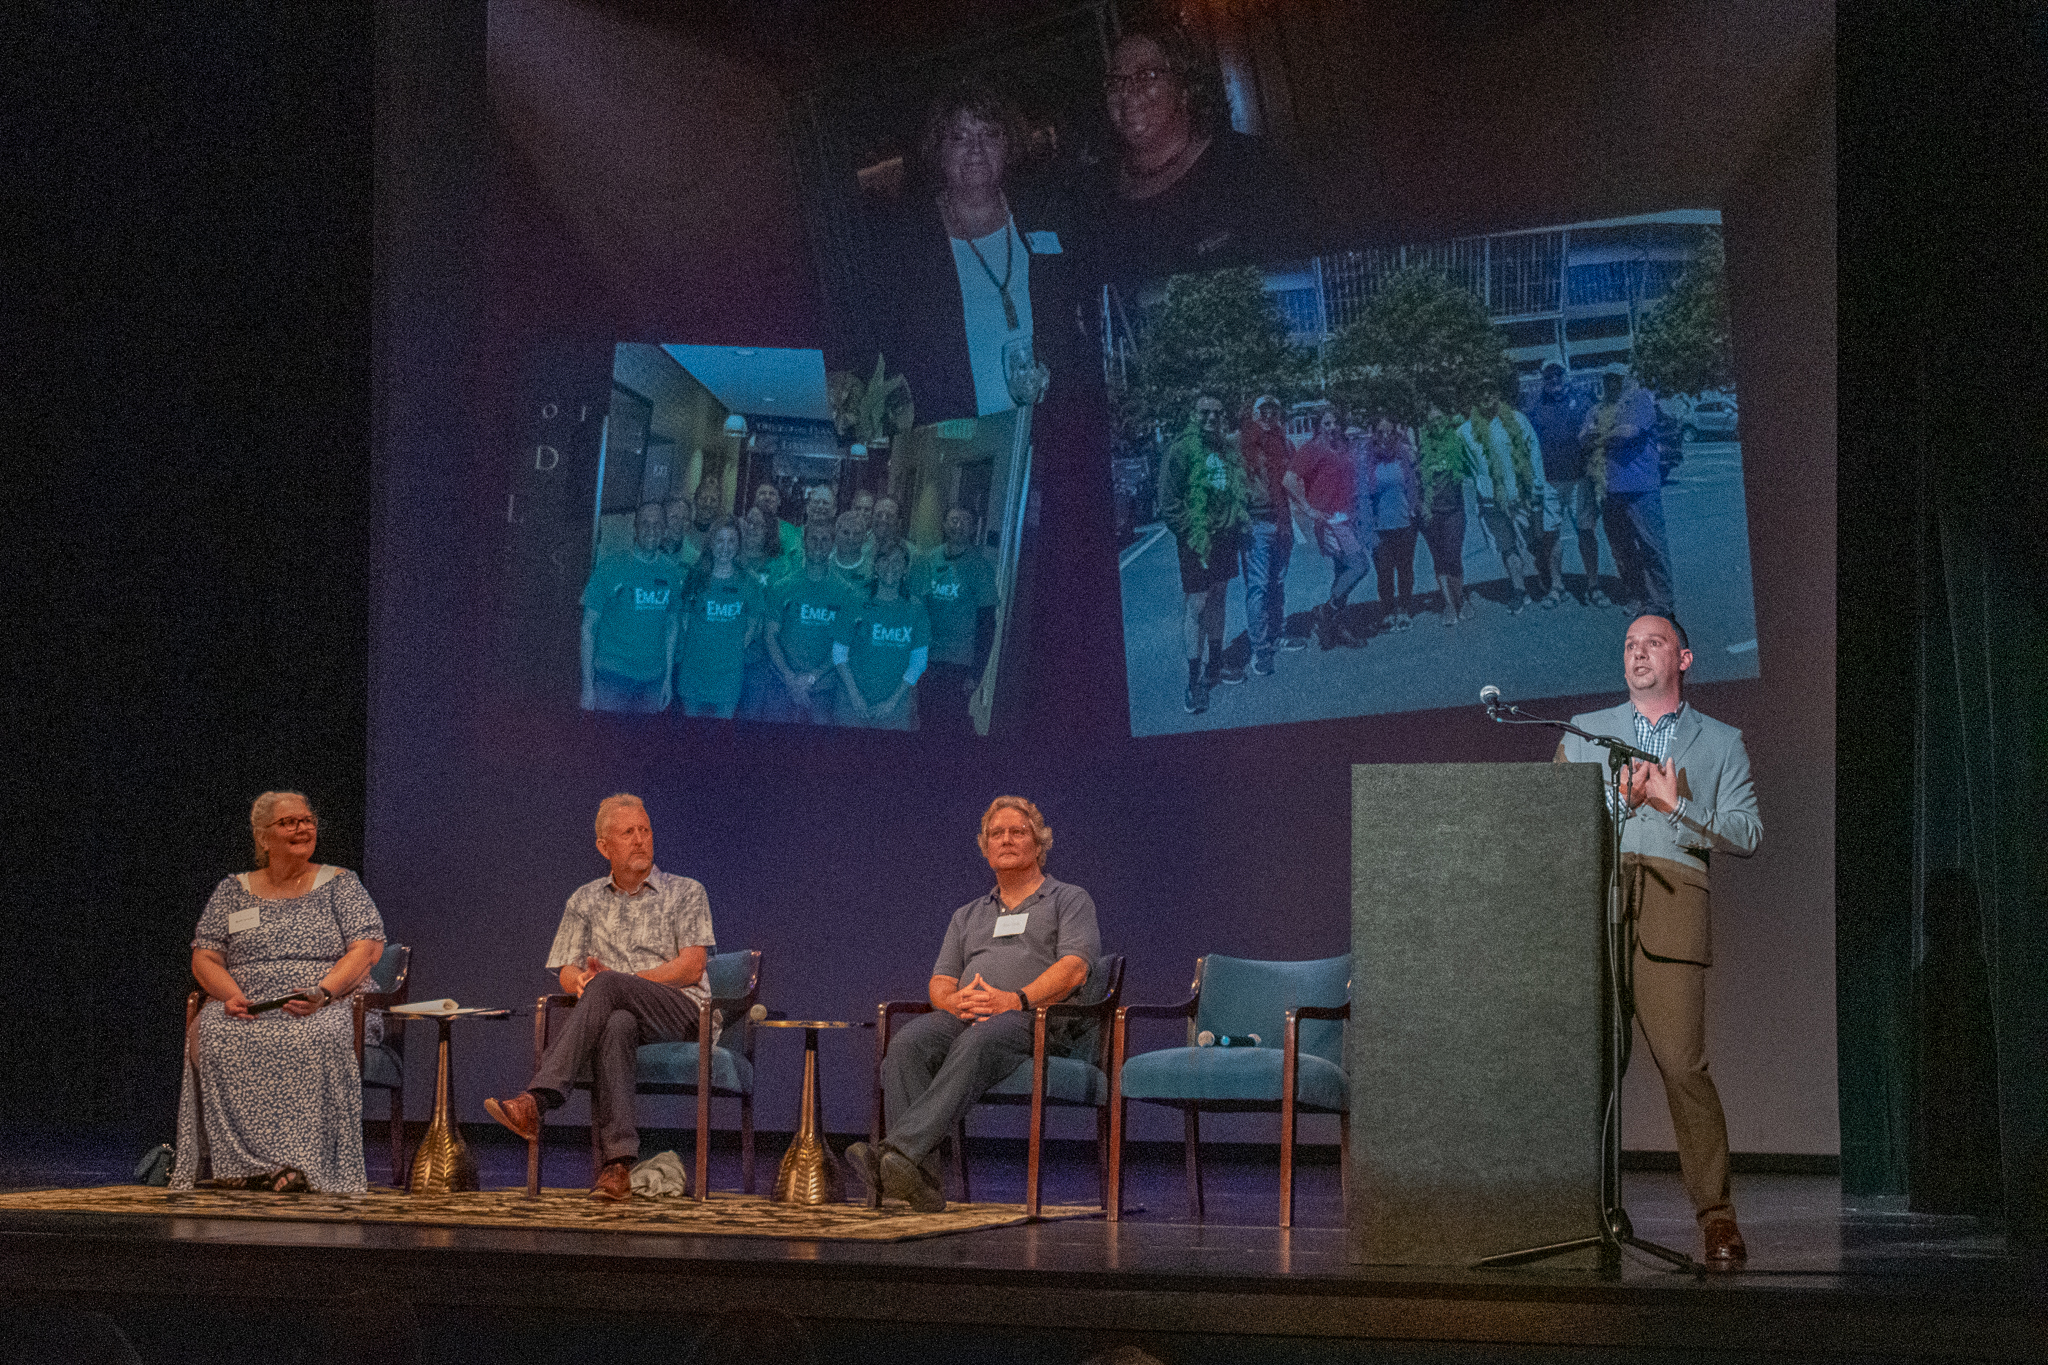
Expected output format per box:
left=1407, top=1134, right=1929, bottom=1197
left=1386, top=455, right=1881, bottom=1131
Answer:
left=170, top=792, right=383, bottom=1193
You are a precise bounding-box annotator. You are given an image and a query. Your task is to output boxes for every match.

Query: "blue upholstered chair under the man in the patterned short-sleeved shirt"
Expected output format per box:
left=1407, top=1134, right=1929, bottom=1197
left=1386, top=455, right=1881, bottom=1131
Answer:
left=526, top=950, right=762, bottom=1199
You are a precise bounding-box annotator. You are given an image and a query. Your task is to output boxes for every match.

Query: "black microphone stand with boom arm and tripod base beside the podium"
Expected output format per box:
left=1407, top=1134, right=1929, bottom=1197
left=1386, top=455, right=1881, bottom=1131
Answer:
left=1473, top=700, right=1706, bottom=1277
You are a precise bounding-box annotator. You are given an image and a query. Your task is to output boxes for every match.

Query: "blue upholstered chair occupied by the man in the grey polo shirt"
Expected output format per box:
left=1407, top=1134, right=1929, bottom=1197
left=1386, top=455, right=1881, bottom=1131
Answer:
left=868, top=954, right=1124, bottom=1218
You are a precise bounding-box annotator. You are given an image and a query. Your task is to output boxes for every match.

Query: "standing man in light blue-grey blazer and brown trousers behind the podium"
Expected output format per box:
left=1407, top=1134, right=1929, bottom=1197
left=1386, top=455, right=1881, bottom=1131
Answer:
left=1556, top=616, right=1763, bottom=1271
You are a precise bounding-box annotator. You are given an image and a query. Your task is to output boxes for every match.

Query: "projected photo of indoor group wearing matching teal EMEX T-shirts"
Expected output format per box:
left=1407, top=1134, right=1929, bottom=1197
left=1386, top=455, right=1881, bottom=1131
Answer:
left=575, top=344, right=1026, bottom=735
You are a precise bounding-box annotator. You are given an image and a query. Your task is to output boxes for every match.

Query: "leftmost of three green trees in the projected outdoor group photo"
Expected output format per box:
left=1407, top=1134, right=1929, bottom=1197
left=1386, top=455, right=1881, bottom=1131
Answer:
left=1120, top=266, right=1313, bottom=438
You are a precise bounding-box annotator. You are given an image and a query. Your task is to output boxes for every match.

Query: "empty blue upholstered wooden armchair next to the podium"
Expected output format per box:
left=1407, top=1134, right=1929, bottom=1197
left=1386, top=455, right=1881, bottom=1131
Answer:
left=1110, top=954, right=1352, bottom=1228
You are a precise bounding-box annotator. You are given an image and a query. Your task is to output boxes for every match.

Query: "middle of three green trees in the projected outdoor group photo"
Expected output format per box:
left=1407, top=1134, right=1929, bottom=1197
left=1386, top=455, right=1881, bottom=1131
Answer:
left=1323, top=266, right=1516, bottom=426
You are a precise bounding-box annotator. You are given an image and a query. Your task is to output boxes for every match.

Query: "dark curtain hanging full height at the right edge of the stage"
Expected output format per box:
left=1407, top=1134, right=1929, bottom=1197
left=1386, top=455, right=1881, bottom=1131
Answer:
left=1837, top=4, right=2048, bottom=1242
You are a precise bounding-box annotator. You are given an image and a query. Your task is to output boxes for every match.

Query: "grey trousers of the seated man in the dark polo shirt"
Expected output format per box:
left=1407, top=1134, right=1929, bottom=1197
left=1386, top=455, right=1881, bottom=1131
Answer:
left=883, top=1009, right=1032, bottom=1169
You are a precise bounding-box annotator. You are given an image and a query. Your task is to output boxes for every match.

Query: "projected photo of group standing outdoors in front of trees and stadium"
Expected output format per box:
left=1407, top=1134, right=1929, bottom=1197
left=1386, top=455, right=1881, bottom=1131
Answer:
left=1106, top=211, right=1757, bottom=735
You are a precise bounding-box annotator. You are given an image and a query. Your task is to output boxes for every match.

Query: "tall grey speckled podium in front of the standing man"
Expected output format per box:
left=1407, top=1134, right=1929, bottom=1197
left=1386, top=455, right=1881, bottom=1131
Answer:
left=1346, top=763, right=1606, bottom=1269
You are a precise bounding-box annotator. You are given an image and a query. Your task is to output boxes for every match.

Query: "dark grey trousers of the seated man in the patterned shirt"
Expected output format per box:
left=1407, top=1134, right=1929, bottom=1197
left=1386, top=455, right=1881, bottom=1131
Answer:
left=526, top=972, right=698, bottom=1160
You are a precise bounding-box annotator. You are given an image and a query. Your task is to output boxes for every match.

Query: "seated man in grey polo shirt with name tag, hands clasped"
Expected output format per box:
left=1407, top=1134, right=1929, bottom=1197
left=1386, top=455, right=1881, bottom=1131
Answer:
left=846, top=796, right=1102, bottom=1214
